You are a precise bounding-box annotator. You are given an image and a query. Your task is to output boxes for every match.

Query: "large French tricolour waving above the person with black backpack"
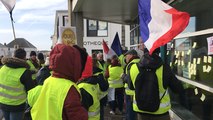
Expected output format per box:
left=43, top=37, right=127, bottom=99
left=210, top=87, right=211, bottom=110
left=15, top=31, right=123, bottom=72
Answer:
left=138, top=0, right=190, bottom=54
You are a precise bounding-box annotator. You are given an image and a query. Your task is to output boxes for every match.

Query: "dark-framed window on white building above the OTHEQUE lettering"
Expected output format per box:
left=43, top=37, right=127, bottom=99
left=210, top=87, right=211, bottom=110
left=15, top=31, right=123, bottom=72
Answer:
left=87, top=20, right=108, bottom=37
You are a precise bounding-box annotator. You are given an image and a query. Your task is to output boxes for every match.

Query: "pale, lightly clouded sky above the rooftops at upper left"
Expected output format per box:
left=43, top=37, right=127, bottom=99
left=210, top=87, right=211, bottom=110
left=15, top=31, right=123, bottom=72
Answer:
left=0, top=0, right=68, bottom=50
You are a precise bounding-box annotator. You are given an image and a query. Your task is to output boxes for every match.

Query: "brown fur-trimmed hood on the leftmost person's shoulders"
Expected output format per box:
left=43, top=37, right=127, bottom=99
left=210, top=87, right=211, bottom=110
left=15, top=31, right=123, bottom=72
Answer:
left=1, top=57, right=30, bottom=69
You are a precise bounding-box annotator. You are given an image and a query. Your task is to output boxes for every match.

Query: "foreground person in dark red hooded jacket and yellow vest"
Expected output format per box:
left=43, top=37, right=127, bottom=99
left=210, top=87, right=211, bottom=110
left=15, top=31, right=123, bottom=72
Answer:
left=28, top=44, right=88, bottom=120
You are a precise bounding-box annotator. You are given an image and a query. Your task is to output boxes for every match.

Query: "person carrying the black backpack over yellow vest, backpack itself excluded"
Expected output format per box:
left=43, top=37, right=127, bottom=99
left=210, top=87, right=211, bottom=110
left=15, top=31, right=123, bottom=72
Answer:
left=129, top=48, right=184, bottom=120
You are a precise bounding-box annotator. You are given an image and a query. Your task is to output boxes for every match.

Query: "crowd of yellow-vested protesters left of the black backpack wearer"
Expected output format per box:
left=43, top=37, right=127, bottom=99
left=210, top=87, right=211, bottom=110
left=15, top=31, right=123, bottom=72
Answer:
left=0, top=41, right=186, bottom=120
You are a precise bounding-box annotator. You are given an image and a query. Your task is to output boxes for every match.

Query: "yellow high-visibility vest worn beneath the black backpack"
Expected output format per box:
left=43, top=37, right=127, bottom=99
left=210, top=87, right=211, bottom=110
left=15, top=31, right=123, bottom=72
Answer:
left=130, top=64, right=171, bottom=114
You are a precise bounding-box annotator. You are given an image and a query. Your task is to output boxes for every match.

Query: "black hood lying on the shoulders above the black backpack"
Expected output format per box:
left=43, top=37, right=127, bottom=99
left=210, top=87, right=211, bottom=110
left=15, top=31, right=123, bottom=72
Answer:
left=139, top=53, right=163, bottom=69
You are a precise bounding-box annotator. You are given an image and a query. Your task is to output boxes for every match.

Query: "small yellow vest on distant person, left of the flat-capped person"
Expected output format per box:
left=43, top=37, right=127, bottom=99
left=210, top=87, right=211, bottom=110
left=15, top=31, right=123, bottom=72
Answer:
left=108, top=65, right=124, bottom=88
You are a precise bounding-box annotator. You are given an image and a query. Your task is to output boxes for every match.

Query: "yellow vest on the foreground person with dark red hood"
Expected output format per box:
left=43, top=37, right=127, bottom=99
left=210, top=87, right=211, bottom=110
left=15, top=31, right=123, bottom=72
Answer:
left=31, top=77, right=80, bottom=120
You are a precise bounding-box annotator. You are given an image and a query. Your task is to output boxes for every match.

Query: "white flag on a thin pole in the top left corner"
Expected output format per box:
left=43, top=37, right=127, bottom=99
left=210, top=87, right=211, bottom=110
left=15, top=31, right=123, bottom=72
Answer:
left=0, top=0, right=16, bottom=40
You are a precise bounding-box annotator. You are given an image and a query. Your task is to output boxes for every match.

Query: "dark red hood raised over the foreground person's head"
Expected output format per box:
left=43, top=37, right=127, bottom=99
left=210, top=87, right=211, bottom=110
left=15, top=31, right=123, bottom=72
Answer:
left=49, top=44, right=82, bottom=82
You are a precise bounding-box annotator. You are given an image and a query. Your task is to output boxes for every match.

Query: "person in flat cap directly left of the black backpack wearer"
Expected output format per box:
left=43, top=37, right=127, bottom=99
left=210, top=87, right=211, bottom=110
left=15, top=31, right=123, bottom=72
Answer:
left=123, top=49, right=140, bottom=120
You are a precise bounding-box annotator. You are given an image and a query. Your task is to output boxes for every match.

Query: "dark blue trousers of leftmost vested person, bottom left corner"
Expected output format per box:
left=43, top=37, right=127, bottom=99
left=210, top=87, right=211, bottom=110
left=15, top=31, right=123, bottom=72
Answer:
left=2, top=110, right=24, bottom=120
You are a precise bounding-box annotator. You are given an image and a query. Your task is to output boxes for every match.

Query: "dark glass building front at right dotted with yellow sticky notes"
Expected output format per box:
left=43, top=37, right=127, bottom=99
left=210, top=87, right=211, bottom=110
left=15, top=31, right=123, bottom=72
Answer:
left=167, top=0, right=213, bottom=120
